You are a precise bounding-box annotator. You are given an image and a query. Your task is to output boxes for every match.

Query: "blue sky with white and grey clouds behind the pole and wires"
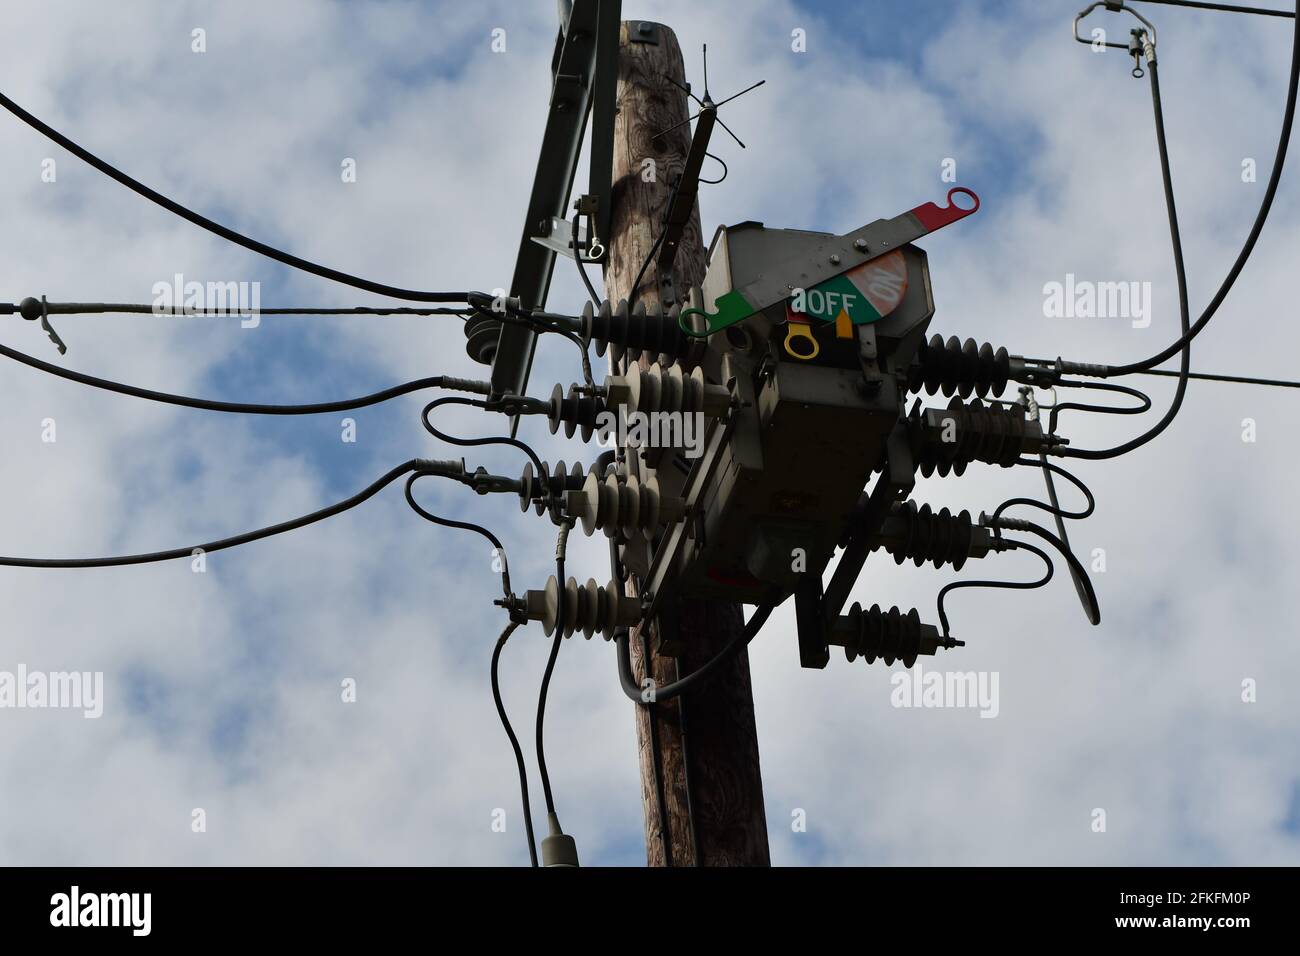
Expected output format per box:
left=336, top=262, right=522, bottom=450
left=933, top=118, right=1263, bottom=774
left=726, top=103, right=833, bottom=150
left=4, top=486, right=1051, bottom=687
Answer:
left=0, top=0, right=1300, bottom=865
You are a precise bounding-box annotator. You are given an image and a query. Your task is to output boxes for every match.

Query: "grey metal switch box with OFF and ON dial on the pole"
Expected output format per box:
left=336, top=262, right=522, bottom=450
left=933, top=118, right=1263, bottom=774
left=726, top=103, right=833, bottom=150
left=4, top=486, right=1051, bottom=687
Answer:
left=675, top=222, right=935, bottom=604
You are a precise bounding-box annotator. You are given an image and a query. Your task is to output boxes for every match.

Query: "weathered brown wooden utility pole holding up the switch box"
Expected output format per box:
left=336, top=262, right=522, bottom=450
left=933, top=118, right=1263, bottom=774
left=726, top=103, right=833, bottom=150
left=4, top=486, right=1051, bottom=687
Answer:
left=605, top=21, right=770, bottom=866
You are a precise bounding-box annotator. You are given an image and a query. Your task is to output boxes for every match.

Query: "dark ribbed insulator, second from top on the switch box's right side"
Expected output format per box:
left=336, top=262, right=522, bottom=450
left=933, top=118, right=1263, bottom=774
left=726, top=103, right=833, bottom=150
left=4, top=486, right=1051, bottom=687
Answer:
left=913, top=398, right=1043, bottom=477
